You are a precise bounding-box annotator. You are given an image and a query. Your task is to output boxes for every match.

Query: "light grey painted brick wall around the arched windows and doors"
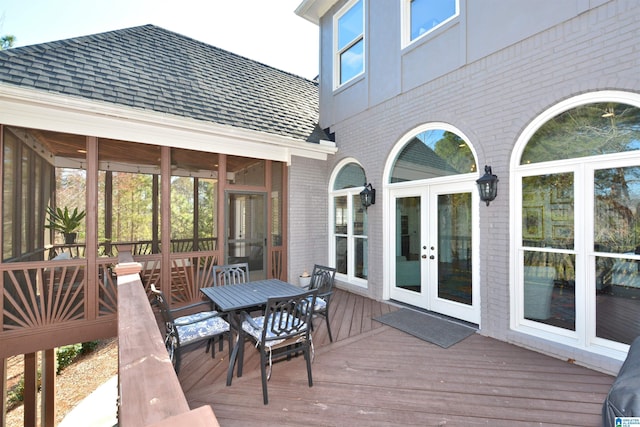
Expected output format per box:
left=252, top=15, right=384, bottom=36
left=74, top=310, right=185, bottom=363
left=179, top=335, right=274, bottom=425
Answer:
left=290, top=0, right=640, bottom=371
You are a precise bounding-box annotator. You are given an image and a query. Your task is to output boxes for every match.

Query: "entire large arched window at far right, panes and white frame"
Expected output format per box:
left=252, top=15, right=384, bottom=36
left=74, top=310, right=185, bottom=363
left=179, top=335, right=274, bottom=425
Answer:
left=513, top=93, right=640, bottom=358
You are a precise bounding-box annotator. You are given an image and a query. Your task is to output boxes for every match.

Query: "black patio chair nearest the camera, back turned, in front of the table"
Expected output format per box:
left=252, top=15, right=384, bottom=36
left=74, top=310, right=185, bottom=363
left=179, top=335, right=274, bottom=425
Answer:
left=240, top=290, right=317, bottom=405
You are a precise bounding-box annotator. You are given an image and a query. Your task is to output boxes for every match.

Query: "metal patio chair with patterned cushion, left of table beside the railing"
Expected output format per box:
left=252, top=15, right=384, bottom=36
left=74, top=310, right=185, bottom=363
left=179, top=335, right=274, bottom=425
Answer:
left=151, top=283, right=231, bottom=374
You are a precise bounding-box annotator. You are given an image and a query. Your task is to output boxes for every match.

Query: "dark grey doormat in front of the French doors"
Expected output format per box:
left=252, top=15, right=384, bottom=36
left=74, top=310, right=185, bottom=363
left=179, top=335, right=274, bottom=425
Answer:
left=373, top=308, right=476, bottom=348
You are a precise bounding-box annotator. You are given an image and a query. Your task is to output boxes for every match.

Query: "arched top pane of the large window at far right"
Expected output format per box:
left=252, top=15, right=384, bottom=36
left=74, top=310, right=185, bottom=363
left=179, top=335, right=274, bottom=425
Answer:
left=520, top=102, right=640, bottom=165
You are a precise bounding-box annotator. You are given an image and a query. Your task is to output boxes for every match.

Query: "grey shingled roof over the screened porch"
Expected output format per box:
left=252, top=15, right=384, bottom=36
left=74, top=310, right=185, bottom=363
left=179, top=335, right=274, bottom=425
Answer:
left=0, top=25, right=328, bottom=142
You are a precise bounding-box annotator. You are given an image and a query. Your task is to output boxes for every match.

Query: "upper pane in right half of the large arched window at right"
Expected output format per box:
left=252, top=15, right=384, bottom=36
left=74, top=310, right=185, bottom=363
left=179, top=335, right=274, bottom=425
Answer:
left=594, top=166, right=640, bottom=254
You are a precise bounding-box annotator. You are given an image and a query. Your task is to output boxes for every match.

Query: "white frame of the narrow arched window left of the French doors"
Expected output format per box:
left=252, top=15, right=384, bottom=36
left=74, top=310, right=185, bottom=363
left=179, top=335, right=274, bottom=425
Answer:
left=328, top=158, right=369, bottom=288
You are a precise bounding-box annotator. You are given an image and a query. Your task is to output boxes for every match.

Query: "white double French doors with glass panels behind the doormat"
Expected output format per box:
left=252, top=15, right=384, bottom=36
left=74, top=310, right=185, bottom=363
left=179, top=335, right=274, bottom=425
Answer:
left=389, top=182, right=480, bottom=324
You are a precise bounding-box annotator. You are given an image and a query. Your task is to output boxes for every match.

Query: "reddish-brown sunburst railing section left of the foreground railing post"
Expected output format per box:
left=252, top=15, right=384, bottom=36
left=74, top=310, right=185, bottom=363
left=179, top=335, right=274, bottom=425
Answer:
left=0, top=258, right=117, bottom=358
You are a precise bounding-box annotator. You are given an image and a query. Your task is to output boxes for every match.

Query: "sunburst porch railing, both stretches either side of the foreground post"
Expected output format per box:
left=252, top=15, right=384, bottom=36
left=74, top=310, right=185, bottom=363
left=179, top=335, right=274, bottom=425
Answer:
left=0, top=247, right=219, bottom=358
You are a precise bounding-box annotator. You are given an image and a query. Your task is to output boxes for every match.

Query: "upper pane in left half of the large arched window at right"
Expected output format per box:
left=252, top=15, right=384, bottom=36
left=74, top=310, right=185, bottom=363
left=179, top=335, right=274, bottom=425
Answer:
left=522, top=173, right=574, bottom=249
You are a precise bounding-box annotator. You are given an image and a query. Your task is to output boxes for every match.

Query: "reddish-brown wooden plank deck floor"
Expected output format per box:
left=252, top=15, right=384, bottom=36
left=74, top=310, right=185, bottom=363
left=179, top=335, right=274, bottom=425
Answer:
left=179, top=291, right=614, bottom=427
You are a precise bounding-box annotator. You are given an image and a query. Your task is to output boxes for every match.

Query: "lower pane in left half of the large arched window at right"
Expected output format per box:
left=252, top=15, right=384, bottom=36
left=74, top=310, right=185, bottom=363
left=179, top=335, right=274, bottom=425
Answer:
left=524, top=251, right=576, bottom=331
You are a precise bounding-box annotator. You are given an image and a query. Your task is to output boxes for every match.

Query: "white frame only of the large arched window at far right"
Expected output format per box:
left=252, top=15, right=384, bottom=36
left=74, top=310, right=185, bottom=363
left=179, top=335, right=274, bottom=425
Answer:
left=509, top=90, right=640, bottom=360
